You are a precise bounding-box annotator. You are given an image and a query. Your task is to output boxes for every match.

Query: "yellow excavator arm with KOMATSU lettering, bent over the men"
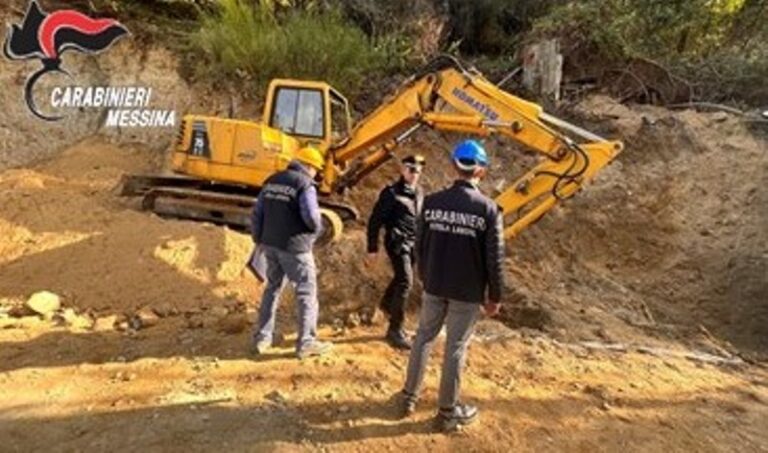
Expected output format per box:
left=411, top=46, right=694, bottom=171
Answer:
left=328, top=57, right=623, bottom=238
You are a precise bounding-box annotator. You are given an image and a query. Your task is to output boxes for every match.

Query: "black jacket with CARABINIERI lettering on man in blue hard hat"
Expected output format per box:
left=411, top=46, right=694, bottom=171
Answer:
left=416, top=181, right=504, bottom=303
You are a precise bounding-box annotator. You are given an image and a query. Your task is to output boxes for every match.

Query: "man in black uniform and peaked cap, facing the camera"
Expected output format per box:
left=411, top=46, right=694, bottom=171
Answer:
left=367, top=155, right=426, bottom=349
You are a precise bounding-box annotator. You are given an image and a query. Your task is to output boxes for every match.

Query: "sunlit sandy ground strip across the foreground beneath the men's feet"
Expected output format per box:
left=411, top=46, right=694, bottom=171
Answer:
left=0, top=319, right=768, bottom=452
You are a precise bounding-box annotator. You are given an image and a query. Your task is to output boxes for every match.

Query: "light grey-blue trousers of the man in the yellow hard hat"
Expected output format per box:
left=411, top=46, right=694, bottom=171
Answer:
left=253, top=245, right=318, bottom=351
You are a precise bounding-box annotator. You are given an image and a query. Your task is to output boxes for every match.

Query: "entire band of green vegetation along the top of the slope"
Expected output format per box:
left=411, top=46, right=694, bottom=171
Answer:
left=93, top=0, right=768, bottom=104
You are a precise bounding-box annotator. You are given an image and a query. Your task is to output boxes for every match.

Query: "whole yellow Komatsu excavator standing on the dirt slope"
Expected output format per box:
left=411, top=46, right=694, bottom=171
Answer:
left=122, top=57, right=623, bottom=240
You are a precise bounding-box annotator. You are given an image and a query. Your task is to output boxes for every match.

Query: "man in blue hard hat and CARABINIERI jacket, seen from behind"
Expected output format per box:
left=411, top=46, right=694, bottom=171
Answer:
left=399, top=140, right=504, bottom=431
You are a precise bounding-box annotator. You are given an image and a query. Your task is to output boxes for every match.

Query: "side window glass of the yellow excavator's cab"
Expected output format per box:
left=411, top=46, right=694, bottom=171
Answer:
left=269, top=87, right=325, bottom=138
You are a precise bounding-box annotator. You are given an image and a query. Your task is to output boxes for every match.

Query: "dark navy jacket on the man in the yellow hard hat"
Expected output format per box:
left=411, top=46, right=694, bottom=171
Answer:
left=251, top=162, right=322, bottom=253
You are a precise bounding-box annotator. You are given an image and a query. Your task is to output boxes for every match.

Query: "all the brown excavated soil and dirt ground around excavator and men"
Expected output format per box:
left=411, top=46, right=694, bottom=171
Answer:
left=0, top=98, right=768, bottom=452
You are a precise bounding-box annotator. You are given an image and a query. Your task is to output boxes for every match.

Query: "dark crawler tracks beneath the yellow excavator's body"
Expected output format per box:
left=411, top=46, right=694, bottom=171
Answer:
left=120, top=175, right=359, bottom=243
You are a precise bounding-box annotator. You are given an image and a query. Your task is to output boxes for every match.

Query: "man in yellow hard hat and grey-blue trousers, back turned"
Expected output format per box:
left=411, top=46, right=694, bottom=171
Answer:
left=251, top=146, right=333, bottom=358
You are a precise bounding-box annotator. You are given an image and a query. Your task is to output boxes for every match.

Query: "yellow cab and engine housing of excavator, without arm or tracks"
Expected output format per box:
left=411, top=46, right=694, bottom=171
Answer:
left=162, top=79, right=351, bottom=197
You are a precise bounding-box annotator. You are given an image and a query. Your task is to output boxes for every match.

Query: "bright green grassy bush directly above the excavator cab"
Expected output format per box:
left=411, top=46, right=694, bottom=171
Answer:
left=192, top=0, right=388, bottom=94
